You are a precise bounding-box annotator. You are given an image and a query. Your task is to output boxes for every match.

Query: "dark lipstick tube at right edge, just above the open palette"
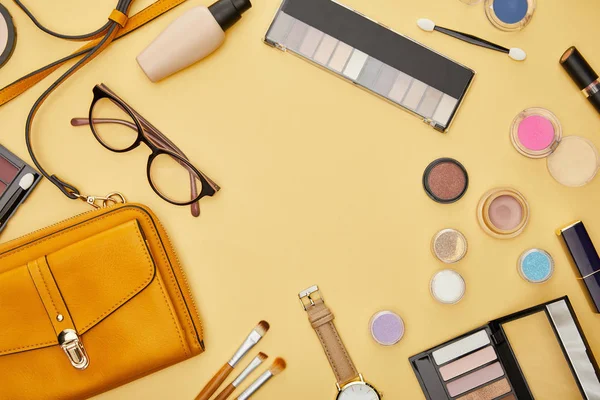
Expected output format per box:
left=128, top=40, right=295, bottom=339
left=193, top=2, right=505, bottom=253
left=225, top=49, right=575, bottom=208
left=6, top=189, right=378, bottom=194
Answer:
left=556, top=221, right=600, bottom=313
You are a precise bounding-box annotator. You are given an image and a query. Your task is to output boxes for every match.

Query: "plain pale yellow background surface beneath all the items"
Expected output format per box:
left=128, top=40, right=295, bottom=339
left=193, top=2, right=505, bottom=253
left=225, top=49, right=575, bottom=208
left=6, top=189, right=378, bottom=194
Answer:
left=0, top=0, right=600, bottom=400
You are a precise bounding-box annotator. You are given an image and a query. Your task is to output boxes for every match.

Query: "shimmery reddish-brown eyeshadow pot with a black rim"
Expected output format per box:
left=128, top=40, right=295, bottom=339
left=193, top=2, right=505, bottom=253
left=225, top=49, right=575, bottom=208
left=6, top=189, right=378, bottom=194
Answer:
left=423, top=157, right=469, bottom=204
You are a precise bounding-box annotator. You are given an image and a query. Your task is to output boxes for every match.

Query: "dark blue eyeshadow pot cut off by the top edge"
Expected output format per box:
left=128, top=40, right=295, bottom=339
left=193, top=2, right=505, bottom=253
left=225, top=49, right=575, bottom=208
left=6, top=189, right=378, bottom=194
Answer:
left=484, top=0, right=536, bottom=32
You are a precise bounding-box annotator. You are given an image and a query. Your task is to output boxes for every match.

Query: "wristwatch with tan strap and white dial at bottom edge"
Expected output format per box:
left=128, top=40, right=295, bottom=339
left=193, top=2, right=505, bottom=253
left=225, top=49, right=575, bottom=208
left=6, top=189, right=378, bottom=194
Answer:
left=298, top=285, right=381, bottom=400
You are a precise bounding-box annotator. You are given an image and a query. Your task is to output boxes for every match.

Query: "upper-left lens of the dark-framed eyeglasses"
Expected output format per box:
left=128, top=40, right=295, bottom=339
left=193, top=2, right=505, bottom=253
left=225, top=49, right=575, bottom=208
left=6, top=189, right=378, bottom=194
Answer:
left=92, top=97, right=138, bottom=151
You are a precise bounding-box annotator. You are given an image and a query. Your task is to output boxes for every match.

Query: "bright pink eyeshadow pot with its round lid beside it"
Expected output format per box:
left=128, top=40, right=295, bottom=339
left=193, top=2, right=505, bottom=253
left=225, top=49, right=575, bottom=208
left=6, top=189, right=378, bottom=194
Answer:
left=510, top=107, right=600, bottom=187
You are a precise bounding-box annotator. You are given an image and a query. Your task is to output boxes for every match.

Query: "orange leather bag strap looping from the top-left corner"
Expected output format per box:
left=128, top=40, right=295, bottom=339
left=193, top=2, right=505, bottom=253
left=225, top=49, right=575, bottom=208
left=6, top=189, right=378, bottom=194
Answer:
left=0, top=0, right=186, bottom=199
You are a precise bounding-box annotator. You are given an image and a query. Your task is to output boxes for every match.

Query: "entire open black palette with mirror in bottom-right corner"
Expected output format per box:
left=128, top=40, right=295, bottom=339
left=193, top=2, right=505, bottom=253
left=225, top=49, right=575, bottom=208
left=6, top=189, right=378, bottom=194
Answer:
left=409, top=297, right=600, bottom=400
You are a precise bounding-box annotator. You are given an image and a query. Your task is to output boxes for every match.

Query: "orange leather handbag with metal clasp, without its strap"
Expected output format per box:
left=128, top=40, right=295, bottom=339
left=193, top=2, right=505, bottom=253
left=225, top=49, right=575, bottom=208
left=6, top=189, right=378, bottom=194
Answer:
left=0, top=204, right=204, bottom=400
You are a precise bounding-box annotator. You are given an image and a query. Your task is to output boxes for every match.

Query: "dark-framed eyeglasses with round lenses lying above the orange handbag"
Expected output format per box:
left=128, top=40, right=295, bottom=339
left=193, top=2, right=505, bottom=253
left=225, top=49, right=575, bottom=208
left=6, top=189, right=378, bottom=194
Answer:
left=71, top=84, right=220, bottom=216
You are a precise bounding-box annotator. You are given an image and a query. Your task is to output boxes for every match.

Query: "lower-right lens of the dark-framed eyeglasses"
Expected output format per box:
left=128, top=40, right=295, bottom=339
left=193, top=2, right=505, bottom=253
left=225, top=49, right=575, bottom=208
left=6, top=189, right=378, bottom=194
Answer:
left=150, top=153, right=202, bottom=204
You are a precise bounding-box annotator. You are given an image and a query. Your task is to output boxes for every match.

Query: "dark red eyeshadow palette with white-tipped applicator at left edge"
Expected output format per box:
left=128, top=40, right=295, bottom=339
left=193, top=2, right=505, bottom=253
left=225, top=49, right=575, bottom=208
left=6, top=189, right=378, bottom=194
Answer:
left=0, top=145, right=41, bottom=232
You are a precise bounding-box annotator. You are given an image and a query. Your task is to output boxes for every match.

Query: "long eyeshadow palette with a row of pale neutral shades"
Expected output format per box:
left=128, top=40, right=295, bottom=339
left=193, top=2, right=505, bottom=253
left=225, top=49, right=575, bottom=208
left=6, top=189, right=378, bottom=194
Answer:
left=265, top=0, right=475, bottom=132
